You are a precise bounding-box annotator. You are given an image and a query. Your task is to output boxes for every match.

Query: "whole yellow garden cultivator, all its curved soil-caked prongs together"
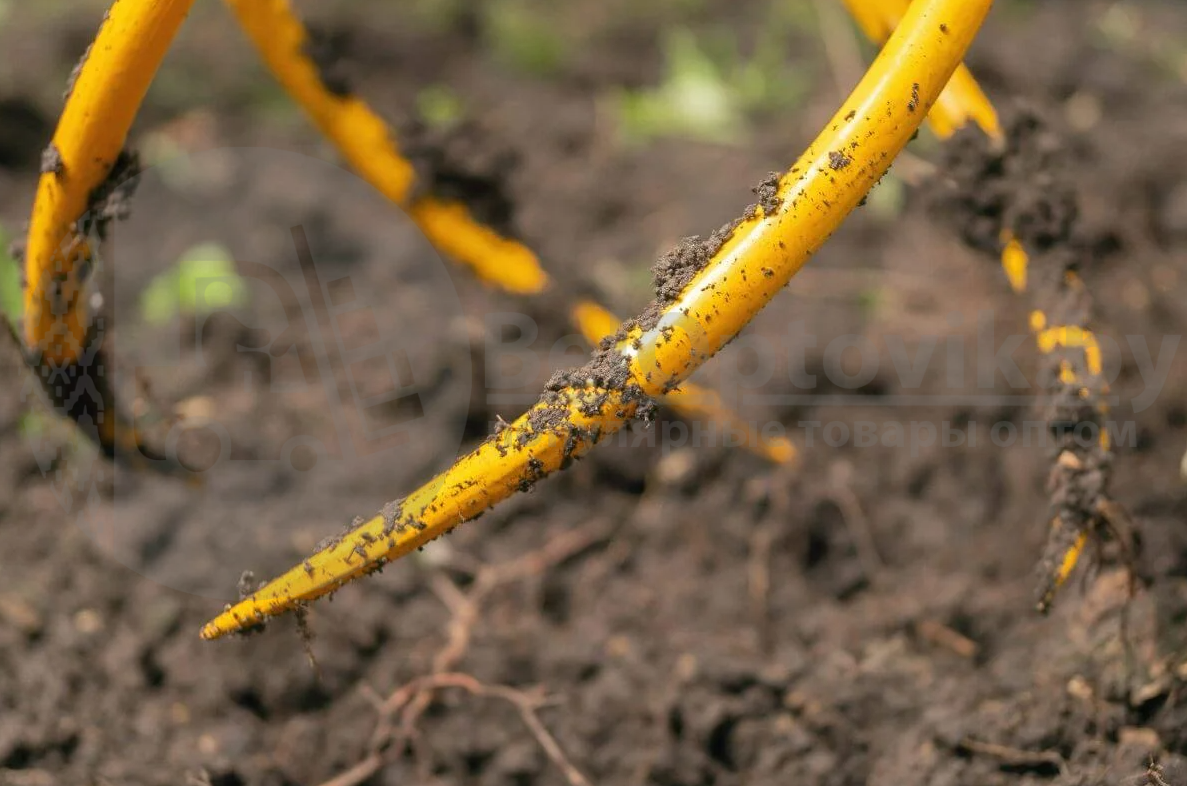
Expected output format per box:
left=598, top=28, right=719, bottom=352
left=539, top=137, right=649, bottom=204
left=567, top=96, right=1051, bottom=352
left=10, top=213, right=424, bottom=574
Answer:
left=16, top=0, right=1111, bottom=638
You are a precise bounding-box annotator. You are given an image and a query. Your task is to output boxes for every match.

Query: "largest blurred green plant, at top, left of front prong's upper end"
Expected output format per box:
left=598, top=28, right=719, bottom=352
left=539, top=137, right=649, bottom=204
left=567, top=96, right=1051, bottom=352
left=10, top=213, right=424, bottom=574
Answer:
left=612, top=18, right=812, bottom=144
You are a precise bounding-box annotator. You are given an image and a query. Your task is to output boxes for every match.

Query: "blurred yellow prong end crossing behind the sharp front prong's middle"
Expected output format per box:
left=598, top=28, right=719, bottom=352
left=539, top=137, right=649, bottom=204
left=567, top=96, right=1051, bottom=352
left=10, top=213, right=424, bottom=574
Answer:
left=572, top=300, right=798, bottom=464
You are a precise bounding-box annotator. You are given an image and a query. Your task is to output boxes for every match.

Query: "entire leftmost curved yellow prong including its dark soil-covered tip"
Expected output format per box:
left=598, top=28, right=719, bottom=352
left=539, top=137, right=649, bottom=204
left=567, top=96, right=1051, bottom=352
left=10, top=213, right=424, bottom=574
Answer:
left=24, top=0, right=192, bottom=469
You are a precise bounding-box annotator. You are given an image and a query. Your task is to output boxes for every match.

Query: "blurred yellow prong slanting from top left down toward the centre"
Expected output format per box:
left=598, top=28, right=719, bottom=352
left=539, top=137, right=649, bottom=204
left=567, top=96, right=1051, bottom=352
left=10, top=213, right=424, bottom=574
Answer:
left=226, top=0, right=548, bottom=294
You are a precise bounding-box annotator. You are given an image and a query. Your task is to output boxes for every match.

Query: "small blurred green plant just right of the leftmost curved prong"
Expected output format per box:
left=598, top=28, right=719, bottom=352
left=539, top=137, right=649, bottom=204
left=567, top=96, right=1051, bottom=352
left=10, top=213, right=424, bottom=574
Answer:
left=140, top=243, right=248, bottom=325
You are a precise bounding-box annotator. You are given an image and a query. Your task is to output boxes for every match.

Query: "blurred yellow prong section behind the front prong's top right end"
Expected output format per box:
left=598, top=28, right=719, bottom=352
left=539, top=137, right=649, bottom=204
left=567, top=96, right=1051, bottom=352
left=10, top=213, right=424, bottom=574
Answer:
left=844, top=0, right=1002, bottom=139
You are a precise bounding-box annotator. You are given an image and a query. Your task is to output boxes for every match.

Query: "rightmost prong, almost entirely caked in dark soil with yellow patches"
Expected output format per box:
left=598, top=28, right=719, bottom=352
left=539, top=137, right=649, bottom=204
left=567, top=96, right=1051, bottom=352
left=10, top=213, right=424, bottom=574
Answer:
left=925, top=113, right=1134, bottom=613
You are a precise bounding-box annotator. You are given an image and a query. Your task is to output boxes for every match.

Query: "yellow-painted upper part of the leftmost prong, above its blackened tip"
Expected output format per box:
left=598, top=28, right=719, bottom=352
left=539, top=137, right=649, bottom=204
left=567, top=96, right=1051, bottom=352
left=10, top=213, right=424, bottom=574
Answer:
left=24, top=0, right=192, bottom=365
